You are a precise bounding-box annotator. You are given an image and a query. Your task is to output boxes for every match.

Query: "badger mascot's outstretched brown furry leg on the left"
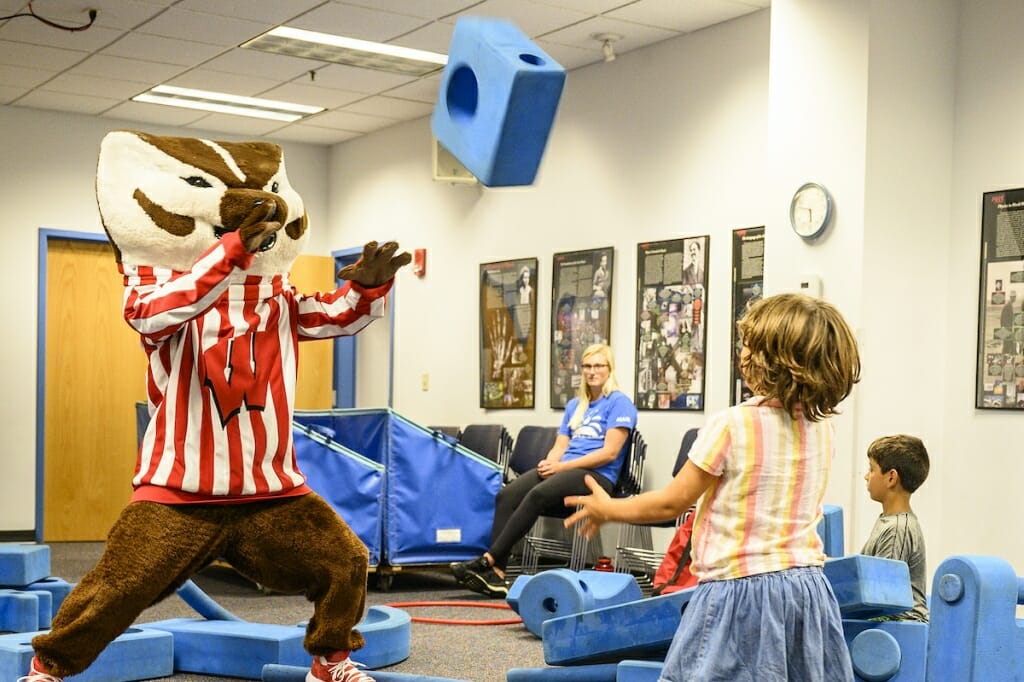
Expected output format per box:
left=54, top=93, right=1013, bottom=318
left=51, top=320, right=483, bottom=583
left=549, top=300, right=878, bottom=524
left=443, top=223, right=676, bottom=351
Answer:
left=32, top=502, right=228, bottom=677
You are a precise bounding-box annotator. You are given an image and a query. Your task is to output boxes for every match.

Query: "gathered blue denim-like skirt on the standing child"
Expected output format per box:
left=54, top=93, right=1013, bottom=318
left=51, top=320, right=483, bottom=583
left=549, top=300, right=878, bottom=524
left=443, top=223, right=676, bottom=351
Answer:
left=660, top=567, right=853, bottom=682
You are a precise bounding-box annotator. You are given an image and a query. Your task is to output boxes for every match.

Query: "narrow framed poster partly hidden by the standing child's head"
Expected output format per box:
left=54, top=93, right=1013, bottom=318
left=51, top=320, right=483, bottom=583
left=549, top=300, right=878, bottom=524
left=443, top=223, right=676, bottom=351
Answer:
left=729, top=225, right=765, bottom=404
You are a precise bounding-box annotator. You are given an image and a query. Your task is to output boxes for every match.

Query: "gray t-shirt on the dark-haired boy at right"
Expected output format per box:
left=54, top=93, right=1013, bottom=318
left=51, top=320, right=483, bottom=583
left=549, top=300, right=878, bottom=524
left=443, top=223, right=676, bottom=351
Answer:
left=860, top=512, right=928, bottom=623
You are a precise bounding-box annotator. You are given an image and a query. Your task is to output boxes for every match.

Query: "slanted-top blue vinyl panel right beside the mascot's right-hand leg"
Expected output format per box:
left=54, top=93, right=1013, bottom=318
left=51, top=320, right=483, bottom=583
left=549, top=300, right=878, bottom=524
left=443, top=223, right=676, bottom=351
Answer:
left=292, top=422, right=384, bottom=566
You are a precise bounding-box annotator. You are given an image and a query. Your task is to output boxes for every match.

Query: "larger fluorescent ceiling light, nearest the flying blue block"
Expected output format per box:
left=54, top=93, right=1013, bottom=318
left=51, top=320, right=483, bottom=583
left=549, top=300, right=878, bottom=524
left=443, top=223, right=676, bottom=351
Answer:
left=242, top=26, right=447, bottom=76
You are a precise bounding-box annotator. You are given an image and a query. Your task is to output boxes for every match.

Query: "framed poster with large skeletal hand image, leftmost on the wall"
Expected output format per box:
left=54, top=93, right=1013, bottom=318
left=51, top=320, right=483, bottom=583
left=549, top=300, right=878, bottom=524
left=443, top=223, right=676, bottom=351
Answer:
left=480, top=258, right=538, bottom=409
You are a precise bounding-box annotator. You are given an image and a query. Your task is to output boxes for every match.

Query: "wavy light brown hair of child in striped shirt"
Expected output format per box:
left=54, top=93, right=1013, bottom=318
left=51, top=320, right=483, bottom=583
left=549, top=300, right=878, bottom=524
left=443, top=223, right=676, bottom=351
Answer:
left=737, top=294, right=860, bottom=422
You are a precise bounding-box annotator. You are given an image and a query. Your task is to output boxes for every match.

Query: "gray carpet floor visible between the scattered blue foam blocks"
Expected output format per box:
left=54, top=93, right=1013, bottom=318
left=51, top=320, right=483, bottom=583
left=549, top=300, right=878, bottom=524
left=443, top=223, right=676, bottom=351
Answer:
left=50, top=543, right=545, bottom=682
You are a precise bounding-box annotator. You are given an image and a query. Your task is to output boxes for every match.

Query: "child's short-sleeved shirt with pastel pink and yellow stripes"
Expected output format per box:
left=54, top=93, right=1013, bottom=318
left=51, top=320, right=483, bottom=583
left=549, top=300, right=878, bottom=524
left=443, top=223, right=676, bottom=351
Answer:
left=689, top=397, right=835, bottom=582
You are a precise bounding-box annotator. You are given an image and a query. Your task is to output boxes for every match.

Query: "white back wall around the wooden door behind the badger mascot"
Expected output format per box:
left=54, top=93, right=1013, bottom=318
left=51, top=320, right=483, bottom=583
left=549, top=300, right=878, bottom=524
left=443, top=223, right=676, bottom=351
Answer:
left=0, top=106, right=328, bottom=530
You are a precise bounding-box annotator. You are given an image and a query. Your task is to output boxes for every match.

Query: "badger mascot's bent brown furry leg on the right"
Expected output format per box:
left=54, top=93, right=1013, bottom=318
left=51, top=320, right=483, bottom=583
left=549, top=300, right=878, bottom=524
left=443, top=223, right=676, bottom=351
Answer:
left=224, top=494, right=370, bottom=655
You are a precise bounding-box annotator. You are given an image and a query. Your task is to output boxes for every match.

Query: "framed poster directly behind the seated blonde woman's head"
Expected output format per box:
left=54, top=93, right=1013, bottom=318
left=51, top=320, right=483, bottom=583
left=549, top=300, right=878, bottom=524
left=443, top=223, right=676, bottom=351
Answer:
left=550, top=247, right=614, bottom=410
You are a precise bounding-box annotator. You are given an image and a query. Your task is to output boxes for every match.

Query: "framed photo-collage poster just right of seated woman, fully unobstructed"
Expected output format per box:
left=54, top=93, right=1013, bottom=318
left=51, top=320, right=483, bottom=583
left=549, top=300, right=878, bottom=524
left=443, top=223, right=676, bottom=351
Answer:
left=634, top=237, right=709, bottom=410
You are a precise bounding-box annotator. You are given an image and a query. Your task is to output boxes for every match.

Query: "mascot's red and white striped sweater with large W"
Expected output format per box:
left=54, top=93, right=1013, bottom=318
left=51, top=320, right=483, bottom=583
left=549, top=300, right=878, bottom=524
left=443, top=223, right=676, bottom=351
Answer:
left=121, top=232, right=390, bottom=504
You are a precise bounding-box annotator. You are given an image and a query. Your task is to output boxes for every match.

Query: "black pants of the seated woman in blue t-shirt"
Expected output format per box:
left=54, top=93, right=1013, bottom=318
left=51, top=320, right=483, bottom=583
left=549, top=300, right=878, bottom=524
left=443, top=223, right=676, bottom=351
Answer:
left=487, top=469, right=612, bottom=570
